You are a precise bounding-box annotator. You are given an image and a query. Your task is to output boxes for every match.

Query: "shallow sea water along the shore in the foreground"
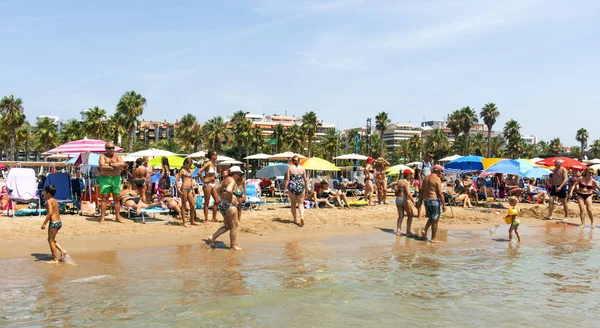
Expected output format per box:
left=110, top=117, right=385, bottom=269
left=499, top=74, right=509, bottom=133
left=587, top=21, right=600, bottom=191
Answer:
left=0, top=223, right=600, bottom=327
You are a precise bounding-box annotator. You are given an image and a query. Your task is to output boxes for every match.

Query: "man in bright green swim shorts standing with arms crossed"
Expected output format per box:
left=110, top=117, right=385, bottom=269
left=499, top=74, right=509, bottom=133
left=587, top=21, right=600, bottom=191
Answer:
left=96, top=142, right=125, bottom=223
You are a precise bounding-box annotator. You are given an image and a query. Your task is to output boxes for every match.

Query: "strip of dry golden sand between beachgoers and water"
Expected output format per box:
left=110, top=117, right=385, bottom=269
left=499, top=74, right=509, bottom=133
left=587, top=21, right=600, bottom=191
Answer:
left=0, top=199, right=600, bottom=258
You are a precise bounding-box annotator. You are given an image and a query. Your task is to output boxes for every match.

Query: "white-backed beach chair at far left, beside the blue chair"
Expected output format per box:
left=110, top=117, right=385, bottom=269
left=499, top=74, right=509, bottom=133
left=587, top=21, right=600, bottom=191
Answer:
left=6, top=167, right=41, bottom=215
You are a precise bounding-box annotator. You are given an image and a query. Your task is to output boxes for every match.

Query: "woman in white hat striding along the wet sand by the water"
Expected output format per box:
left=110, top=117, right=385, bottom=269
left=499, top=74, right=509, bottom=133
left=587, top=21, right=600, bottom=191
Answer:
left=207, top=166, right=244, bottom=251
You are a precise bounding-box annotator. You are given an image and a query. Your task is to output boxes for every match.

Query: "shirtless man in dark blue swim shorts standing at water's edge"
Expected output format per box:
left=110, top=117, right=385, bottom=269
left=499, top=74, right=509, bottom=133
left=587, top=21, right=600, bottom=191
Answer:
left=417, top=165, right=446, bottom=243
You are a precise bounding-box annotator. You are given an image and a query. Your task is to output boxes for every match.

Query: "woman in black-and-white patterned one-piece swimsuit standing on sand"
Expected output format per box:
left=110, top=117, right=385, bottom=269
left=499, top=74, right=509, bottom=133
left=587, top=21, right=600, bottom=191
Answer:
left=284, top=155, right=308, bottom=227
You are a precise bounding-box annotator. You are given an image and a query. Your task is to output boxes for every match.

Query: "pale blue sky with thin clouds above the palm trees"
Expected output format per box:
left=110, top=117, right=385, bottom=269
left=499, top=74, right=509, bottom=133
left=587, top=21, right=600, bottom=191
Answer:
left=0, top=0, right=600, bottom=146
